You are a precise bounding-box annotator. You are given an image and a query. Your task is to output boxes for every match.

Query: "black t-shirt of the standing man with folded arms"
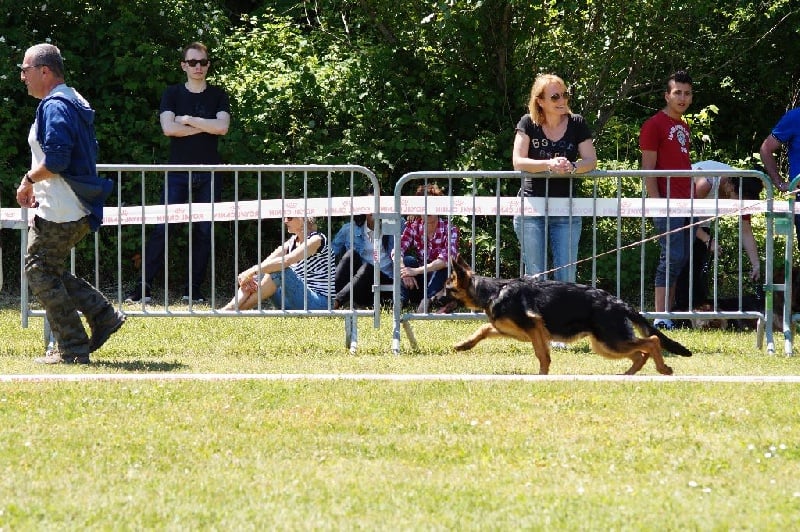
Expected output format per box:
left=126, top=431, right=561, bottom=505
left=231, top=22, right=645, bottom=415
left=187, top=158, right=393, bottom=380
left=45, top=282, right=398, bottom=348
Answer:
left=158, top=83, right=230, bottom=164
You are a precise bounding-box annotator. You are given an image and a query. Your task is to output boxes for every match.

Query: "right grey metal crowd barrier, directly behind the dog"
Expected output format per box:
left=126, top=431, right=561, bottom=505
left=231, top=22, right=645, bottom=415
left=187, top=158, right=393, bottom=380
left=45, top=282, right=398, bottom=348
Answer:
left=387, top=170, right=792, bottom=355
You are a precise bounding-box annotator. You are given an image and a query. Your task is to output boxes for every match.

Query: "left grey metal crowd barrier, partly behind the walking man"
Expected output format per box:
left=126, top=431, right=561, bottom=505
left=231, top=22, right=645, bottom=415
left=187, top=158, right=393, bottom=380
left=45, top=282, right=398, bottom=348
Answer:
left=14, top=164, right=381, bottom=351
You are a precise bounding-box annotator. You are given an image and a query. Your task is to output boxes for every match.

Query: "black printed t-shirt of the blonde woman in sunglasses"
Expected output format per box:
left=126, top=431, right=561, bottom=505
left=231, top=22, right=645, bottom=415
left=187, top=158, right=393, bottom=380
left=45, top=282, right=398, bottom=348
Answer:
left=517, top=114, right=592, bottom=198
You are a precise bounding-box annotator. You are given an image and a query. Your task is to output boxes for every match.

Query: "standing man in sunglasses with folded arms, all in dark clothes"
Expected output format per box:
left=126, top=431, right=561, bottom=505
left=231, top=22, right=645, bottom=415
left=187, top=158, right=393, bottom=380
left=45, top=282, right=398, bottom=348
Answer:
left=126, top=42, right=230, bottom=303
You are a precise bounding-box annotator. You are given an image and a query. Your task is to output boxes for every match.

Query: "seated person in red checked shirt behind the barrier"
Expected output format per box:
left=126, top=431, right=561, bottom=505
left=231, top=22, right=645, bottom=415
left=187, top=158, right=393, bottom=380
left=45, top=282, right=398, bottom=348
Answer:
left=400, top=184, right=458, bottom=312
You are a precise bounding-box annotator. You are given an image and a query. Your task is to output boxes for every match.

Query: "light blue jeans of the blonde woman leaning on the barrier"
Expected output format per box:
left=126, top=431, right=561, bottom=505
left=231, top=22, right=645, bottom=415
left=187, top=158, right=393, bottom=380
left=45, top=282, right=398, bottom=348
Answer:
left=514, top=216, right=583, bottom=283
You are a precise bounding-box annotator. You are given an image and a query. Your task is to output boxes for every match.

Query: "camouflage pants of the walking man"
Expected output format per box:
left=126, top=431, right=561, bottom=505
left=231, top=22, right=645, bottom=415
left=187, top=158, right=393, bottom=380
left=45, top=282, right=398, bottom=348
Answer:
left=25, top=216, right=114, bottom=356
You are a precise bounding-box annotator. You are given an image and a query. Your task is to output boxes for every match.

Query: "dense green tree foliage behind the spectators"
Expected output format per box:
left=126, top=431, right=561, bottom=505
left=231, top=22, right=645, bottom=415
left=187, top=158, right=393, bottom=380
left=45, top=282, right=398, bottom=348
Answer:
left=0, top=0, right=800, bottom=290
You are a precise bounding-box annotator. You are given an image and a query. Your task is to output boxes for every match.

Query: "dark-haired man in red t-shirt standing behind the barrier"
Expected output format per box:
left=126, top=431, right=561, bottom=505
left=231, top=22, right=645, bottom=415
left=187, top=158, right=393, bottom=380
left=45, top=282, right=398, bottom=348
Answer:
left=639, top=70, right=694, bottom=329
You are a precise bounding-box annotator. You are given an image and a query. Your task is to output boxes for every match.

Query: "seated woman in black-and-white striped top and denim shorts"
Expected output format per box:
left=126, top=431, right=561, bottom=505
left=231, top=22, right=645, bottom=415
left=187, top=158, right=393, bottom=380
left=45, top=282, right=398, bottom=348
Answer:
left=221, top=216, right=334, bottom=311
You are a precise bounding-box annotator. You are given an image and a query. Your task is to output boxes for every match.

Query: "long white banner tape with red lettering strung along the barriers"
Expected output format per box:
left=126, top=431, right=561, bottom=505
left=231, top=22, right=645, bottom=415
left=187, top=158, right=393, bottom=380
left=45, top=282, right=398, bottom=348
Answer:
left=0, top=196, right=788, bottom=227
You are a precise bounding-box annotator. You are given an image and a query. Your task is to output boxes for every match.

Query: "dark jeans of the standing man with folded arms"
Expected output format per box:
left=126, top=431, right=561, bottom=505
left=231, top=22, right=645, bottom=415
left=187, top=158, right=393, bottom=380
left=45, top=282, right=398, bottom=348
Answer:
left=142, top=172, right=222, bottom=294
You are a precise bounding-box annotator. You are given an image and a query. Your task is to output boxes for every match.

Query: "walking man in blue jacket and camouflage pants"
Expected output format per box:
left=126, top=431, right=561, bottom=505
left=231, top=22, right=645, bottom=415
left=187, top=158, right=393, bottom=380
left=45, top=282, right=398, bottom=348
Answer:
left=17, top=44, right=125, bottom=364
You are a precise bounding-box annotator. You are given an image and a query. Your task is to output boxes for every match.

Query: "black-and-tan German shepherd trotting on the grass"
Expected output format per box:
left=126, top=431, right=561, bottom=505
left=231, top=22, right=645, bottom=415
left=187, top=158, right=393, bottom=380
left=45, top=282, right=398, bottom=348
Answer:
left=440, top=256, right=692, bottom=375
